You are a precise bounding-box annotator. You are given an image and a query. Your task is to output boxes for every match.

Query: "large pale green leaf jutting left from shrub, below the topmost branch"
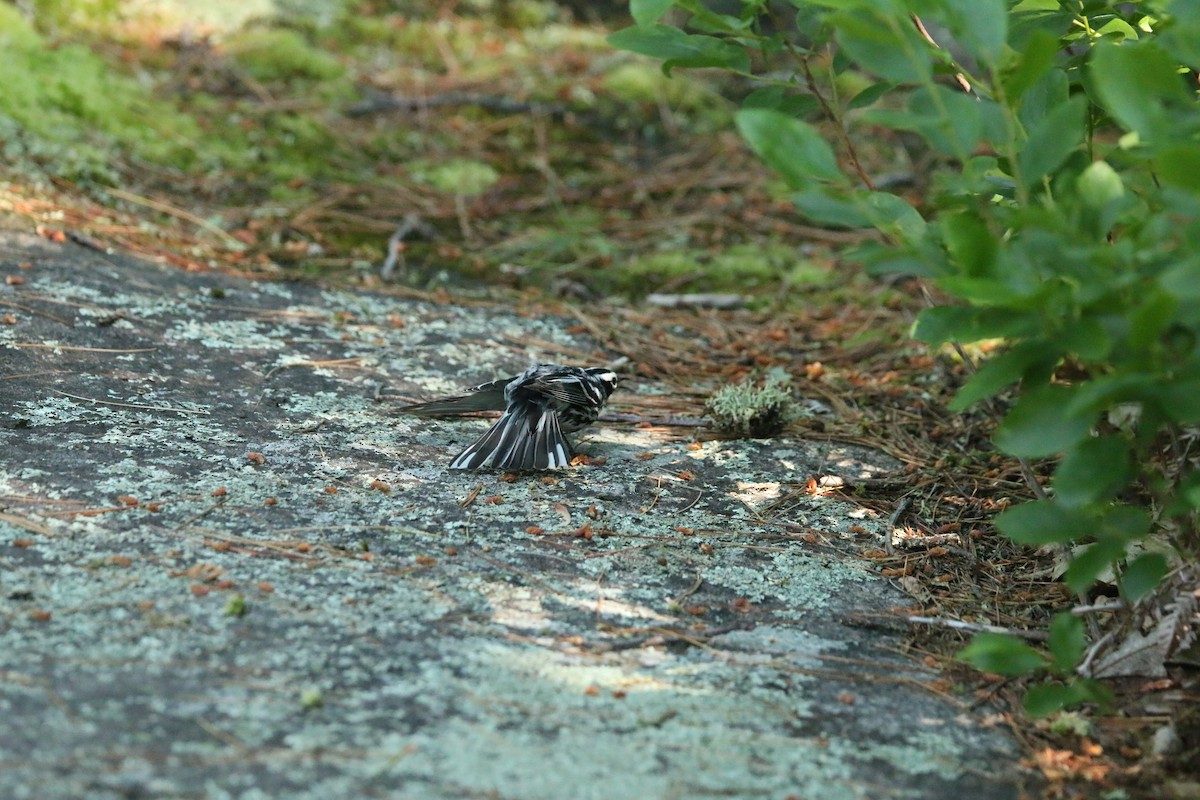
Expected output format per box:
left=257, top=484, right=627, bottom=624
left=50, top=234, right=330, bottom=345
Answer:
left=734, top=108, right=850, bottom=190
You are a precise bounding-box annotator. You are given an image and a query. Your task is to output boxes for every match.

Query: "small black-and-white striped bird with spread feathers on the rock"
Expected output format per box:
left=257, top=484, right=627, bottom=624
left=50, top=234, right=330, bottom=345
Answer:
left=398, top=363, right=617, bottom=471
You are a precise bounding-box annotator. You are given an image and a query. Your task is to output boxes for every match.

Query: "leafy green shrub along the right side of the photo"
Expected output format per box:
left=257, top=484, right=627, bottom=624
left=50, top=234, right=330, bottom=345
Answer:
left=610, top=0, right=1200, bottom=712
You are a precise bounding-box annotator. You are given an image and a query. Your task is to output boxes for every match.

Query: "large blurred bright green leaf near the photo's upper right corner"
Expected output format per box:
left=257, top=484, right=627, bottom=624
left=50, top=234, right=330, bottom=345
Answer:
left=1088, top=42, right=1195, bottom=142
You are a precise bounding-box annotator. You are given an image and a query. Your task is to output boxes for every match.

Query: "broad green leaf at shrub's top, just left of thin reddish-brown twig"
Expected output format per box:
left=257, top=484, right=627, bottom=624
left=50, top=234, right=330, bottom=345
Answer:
left=828, top=8, right=934, bottom=83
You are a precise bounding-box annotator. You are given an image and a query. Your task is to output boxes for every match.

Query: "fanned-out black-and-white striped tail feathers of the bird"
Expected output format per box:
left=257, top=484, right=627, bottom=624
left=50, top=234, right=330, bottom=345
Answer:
left=450, top=403, right=575, bottom=470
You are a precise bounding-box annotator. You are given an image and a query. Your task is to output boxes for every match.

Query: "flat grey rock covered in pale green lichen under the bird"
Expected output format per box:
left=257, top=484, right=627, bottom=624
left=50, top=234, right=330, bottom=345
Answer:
left=0, top=227, right=1024, bottom=800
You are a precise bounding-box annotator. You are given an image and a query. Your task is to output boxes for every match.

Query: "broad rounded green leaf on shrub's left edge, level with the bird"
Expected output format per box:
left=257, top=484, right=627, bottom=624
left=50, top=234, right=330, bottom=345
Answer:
left=994, top=386, right=1096, bottom=458
